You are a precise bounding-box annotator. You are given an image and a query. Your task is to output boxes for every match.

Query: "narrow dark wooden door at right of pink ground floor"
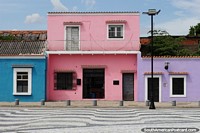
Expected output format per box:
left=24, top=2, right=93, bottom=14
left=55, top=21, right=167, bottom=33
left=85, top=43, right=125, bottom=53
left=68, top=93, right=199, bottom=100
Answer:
left=122, top=73, right=134, bottom=101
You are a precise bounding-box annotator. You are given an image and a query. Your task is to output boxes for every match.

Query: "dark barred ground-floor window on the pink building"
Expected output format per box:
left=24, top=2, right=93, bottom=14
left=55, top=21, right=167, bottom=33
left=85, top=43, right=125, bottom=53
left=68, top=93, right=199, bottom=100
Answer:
left=54, top=72, right=77, bottom=90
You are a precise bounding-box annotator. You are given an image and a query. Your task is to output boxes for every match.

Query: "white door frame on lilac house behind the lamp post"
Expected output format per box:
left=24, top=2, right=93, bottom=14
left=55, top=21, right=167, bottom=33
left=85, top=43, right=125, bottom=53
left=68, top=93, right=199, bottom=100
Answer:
left=145, top=75, right=162, bottom=102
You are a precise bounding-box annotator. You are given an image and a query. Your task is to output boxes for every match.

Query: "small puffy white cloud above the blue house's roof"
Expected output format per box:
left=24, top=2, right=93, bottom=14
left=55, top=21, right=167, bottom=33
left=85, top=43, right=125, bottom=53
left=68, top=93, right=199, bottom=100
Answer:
left=24, top=13, right=43, bottom=24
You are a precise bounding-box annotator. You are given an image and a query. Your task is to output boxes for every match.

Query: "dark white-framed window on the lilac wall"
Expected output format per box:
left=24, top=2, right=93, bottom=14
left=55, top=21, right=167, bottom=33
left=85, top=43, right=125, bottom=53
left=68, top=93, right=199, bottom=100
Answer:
left=170, top=76, right=186, bottom=97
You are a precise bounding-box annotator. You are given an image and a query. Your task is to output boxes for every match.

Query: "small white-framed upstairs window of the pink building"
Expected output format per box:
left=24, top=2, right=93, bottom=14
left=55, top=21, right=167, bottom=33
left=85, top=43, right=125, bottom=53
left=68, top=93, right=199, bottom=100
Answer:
left=108, top=25, right=124, bottom=38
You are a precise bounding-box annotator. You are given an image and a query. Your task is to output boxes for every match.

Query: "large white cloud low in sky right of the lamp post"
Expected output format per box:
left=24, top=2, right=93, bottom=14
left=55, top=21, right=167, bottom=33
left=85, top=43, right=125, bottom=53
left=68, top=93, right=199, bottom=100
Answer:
left=155, top=17, right=200, bottom=35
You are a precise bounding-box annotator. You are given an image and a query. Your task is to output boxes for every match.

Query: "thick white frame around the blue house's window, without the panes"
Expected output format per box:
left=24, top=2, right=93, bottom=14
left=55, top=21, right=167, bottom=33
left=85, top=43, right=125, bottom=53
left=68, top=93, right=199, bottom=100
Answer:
left=13, top=68, right=32, bottom=95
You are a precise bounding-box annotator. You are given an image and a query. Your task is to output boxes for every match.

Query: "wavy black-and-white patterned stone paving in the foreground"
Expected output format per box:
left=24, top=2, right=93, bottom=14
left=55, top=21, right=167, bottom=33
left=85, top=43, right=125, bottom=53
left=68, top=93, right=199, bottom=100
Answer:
left=0, top=107, right=200, bottom=133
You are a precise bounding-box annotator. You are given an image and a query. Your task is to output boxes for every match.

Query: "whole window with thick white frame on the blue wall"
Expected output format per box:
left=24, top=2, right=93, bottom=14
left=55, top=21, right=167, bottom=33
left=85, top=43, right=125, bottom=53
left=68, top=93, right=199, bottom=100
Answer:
left=13, top=68, right=32, bottom=95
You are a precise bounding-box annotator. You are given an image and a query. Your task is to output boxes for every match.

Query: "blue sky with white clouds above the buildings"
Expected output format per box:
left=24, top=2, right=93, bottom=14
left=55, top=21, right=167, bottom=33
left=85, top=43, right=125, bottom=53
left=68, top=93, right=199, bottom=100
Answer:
left=0, top=0, right=200, bottom=36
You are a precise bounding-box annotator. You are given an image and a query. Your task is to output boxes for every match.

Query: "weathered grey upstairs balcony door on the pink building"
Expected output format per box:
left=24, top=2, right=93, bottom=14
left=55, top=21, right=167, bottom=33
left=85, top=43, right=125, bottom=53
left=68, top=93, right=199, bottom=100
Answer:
left=65, top=26, right=80, bottom=51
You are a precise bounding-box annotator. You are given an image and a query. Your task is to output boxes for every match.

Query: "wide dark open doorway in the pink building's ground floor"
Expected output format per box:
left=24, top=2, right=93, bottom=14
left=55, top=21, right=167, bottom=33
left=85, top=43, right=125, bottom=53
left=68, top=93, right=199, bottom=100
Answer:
left=83, top=69, right=105, bottom=99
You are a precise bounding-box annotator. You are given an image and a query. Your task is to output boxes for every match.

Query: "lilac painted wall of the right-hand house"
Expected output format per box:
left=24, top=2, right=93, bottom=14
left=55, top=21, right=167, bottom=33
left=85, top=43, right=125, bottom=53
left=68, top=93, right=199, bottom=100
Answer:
left=138, top=57, right=200, bottom=102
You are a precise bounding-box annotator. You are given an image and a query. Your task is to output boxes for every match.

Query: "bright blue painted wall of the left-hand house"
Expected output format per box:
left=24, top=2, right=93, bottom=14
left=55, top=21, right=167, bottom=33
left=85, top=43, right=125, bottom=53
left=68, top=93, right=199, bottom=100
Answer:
left=0, top=59, right=46, bottom=102
